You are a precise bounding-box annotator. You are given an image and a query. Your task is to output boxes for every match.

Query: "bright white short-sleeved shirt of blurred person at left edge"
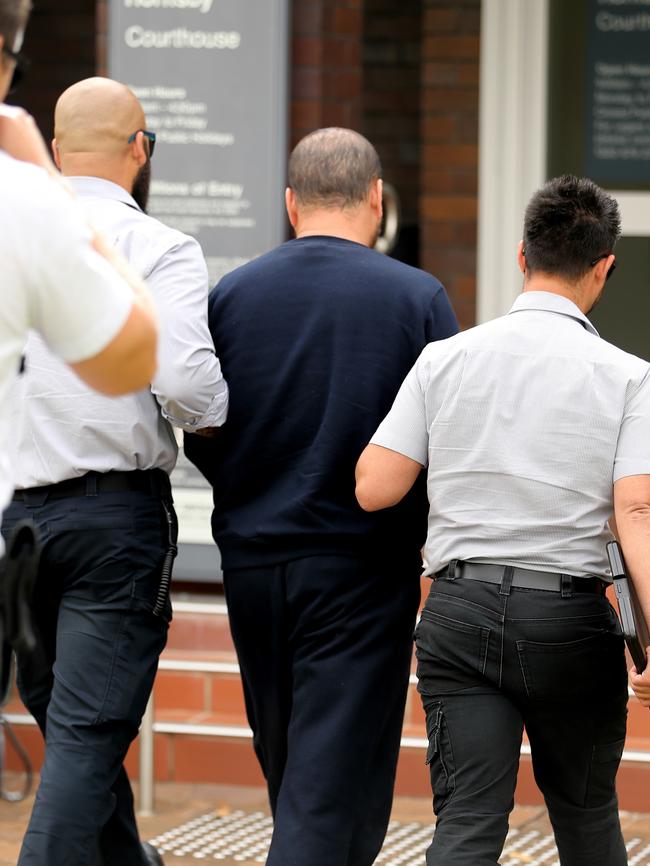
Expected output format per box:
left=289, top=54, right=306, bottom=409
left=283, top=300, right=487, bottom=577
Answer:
left=0, top=151, right=133, bottom=536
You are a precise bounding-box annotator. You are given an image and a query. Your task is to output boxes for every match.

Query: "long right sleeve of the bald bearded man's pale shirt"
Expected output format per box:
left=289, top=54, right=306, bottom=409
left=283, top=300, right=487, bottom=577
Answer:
left=147, top=236, right=228, bottom=431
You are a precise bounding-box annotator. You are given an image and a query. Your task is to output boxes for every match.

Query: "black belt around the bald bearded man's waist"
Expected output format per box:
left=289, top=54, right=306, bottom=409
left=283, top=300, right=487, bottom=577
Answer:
left=13, top=469, right=171, bottom=502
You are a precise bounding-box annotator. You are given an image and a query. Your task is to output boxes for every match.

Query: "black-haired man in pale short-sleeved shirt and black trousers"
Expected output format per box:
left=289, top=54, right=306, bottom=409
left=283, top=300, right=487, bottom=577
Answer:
left=357, top=176, right=650, bottom=866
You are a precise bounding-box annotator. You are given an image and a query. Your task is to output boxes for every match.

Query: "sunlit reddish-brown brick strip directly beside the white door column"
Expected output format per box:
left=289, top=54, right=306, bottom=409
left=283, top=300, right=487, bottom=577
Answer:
left=420, top=0, right=480, bottom=328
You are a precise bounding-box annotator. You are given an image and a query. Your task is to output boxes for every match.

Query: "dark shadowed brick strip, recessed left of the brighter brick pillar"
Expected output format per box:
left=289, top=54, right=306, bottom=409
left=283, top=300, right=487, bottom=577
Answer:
left=361, top=0, right=421, bottom=265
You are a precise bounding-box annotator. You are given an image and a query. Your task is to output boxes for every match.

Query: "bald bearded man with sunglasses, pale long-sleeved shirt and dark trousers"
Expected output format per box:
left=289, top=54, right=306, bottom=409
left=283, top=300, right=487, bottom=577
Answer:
left=1, top=72, right=228, bottom=866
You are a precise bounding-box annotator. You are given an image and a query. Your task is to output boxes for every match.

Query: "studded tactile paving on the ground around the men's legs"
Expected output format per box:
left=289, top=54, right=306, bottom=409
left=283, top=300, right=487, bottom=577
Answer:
left=150, top=810, right=650, bottom=866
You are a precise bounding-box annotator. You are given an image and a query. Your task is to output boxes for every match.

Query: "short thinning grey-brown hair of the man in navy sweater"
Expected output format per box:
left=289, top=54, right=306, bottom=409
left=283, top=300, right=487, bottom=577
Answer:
left=289, top=127, right=381, bottom=208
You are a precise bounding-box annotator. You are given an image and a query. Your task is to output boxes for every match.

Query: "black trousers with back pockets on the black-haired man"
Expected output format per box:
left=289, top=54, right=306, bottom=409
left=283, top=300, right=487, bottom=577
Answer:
left=416, top=578, right=627, bottom=866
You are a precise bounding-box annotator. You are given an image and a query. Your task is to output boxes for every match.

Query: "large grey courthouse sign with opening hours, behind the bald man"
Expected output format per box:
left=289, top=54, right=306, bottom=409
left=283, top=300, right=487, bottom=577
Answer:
left=108, top=0, right=289, bottom=579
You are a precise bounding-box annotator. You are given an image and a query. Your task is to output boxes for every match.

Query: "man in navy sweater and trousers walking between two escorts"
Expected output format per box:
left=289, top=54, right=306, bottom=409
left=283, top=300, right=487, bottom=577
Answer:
left=186, top=129, right=458, bottom=866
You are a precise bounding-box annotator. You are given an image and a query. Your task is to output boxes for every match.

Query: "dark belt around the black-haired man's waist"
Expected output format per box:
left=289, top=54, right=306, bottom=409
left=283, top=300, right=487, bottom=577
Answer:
left=436, top=560, right=607, bottom=595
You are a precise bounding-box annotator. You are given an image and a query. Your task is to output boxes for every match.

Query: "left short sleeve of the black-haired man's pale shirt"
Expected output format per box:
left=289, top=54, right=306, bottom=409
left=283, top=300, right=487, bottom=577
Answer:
left=370, top=355, right=429, bottom=466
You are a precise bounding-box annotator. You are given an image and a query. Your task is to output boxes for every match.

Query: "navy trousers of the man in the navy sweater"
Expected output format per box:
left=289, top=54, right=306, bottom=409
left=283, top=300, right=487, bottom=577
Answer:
left=224, top=555, right=420, bottom=866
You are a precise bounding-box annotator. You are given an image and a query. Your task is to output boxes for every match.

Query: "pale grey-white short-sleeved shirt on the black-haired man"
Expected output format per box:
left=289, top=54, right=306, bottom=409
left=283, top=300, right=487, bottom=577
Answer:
left=372, top=292, right=650, bottom=577
